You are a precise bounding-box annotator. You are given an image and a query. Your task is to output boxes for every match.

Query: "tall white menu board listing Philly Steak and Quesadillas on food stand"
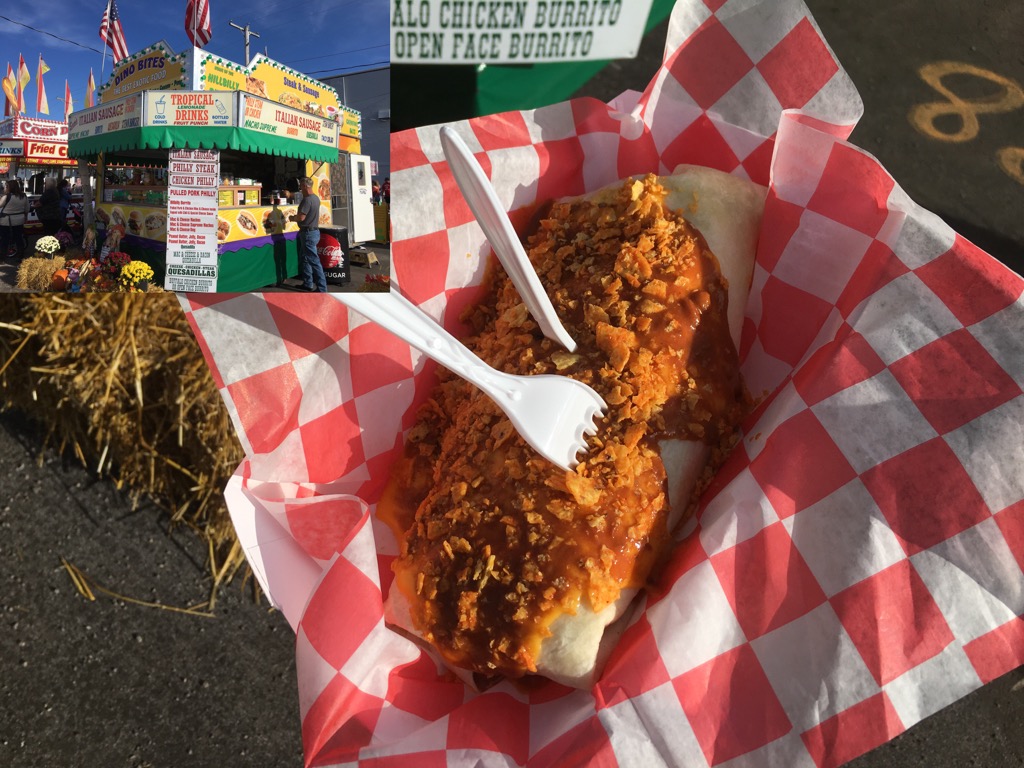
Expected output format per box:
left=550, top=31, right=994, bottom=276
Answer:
left=164, top=150, right=220, bottom=293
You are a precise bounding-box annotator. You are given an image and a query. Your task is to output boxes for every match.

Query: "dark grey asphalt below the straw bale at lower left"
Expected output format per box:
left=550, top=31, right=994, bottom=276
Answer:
left=0, top=414, right=302, bottom=768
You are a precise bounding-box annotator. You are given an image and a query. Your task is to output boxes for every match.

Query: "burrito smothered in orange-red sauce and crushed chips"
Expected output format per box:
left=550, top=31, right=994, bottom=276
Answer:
left=377, top=167, right=765, bottom=688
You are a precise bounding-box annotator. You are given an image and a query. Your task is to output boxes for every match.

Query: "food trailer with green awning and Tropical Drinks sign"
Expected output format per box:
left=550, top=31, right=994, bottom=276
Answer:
left=68, top=42, right=374, bottom=292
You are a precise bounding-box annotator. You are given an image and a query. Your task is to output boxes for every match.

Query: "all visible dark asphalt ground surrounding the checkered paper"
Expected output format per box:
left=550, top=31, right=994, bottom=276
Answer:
left=0, top=0, right=1024, bottom=768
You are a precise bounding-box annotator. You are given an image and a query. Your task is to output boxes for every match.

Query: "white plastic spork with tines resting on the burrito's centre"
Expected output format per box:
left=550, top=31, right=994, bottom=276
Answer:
left=328, top=290, right=607, bottom=472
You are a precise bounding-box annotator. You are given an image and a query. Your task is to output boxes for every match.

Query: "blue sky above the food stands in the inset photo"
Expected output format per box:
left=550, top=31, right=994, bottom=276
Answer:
left=0, top=0, right=390, bottom=120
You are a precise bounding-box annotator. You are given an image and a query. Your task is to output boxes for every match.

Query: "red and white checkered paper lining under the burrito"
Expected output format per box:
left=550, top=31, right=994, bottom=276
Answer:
left=182, top=0, right=1024, bottom=768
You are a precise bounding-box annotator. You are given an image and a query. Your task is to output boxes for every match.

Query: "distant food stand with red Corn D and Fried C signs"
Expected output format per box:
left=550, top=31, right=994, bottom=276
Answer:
left=0, top=115, right=82, bottom=236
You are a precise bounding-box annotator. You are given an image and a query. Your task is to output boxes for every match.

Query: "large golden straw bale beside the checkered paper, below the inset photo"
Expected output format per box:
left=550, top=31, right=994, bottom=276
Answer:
left=0, top=290, right=244, bottom=599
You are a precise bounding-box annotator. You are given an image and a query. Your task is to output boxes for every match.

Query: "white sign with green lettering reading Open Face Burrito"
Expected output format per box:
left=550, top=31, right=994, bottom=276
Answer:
left=391, top=0, right=653, bottom=65
